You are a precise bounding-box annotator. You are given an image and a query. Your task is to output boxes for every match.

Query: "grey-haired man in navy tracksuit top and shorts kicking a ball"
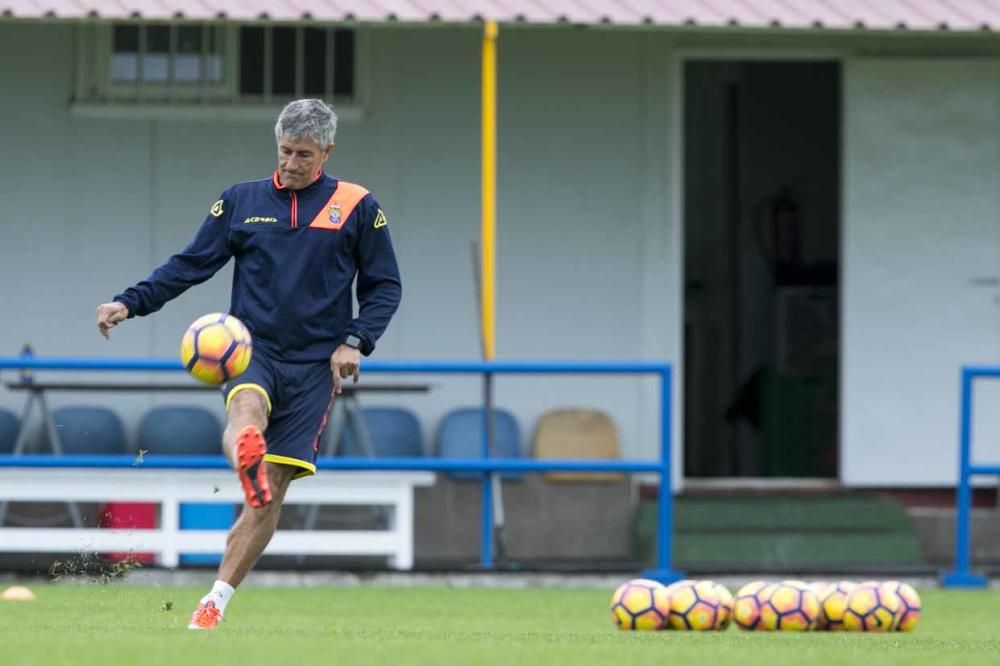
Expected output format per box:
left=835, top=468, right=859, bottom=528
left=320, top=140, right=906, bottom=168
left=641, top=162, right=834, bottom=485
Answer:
left=97, top=99, right=401, bottom=629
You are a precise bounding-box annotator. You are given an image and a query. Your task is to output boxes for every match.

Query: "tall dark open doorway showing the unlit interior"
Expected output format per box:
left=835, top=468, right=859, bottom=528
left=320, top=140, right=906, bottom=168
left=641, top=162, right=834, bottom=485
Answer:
left=684, top=60, right=841, bottom=478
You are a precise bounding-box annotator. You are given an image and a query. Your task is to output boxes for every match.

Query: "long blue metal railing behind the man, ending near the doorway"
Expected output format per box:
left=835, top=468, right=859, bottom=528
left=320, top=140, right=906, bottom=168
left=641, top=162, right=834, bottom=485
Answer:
left=0, top=356, right=681, bottom=581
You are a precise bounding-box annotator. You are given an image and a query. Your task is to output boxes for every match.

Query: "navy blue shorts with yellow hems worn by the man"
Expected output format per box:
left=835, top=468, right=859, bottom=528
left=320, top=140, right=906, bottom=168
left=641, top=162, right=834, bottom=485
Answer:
left=223, top=349, right=333, bottom=479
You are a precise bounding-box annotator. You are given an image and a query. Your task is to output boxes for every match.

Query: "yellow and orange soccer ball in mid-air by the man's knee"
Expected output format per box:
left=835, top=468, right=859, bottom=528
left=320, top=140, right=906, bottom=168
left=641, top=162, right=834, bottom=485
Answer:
left=181, top=312, right=253, bottom=384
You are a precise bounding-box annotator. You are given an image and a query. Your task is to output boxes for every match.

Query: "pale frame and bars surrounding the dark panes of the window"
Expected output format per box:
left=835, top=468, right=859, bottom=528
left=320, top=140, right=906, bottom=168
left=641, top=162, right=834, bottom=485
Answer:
left=70, top=21, right=371, bottom=120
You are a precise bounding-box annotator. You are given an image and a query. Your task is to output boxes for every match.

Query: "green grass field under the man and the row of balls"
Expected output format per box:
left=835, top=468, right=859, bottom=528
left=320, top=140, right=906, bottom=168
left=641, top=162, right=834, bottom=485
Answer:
left=0, top=584, right=1000, bottom=666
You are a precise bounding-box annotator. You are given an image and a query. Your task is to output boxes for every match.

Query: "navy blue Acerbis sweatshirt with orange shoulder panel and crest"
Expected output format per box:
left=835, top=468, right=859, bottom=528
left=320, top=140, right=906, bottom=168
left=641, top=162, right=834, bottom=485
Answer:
left=115, top=172, right=402, bottom=362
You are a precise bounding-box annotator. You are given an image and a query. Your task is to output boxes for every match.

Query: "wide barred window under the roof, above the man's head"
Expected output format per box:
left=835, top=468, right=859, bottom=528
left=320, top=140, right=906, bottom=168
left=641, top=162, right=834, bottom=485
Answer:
left=75, top=22, right=358, bottom=106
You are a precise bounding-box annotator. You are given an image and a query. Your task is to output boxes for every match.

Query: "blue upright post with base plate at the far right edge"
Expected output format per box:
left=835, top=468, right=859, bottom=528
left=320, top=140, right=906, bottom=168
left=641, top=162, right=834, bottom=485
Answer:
left=941, top=367, right=988, bottom=587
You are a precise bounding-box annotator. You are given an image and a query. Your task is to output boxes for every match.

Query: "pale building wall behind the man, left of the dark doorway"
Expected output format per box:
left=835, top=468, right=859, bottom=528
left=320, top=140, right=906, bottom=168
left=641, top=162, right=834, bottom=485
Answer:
left=0, top=24, right=680, bottom=466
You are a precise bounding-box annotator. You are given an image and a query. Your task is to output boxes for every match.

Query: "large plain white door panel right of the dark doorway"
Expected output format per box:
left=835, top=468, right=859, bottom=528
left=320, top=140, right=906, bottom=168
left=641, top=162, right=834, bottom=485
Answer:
left=841, top=59, right=1000, bottom=486
